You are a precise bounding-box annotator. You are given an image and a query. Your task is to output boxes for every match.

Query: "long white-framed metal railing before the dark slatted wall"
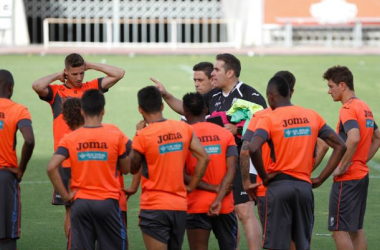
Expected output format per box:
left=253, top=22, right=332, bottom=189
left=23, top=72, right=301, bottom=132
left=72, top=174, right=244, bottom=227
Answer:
left=43, top=18, right=242, bottom=49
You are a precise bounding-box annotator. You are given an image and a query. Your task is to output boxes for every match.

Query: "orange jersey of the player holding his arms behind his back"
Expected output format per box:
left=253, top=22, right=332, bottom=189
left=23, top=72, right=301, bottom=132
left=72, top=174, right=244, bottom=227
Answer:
left=186, top=122, right=238, bottom=214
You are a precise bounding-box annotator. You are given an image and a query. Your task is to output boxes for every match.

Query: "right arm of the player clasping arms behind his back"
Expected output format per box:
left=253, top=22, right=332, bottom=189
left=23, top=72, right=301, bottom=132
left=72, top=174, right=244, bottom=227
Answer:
left=207, top=155, right=237, bottom=216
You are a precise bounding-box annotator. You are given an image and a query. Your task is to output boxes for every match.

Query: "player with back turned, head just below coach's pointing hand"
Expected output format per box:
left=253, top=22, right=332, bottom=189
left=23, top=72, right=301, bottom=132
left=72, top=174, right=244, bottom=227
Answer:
left=129, top=86, right=209, bottom=249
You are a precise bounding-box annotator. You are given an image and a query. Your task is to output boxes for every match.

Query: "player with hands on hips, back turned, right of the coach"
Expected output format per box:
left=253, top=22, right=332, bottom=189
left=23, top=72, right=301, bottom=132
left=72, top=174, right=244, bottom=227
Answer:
left=249, top=76, right=346, bottom=249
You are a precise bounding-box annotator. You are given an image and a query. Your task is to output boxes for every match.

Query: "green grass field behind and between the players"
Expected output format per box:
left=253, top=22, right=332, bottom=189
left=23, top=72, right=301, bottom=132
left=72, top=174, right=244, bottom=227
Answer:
left=0, top=55, right=380, bottom=250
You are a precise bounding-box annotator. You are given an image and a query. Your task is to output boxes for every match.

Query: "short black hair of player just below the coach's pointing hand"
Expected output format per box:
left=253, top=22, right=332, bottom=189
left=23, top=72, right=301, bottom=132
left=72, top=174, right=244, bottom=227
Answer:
left=137, top=86, right=162, bottom=113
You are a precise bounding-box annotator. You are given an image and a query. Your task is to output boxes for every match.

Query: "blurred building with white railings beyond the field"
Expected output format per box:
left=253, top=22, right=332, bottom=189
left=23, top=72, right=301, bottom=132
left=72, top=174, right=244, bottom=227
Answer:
left=0, top=0, right=380, bottom=49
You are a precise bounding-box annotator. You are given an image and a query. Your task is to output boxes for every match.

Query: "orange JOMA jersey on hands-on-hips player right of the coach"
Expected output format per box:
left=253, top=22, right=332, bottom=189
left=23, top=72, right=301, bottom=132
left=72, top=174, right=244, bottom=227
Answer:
left=255, top=106, right=331, bottom=183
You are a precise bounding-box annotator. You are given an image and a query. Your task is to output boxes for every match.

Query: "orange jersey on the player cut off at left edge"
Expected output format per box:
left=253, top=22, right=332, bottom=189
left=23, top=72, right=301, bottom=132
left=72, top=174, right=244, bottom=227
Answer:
left=0, top=98, right=32, bottom=168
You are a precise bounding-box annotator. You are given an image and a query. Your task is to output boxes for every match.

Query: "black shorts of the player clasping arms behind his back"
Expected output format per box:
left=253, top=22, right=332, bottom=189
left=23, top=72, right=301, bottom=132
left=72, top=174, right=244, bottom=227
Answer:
left=186, top=212, right=238, bottom=250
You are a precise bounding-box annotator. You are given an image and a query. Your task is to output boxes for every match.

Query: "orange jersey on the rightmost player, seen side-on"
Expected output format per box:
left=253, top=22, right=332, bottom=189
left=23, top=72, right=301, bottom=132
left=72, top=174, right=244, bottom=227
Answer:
left=334, top=98, right=375, bottom=181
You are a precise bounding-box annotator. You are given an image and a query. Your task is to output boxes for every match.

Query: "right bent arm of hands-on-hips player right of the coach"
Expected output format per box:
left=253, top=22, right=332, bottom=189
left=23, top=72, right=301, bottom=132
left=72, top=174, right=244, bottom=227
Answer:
left=311, top=130, right=346, bottom=188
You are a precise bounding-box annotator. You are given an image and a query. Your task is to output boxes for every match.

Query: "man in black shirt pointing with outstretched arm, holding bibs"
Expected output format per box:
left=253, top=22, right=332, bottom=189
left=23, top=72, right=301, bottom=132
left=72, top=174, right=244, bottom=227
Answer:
left=155, top=54, right=266, bottom=249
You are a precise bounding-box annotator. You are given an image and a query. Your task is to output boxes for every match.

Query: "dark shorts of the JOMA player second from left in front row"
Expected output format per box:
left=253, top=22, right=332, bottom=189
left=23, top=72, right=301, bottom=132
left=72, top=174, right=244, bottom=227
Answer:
left=68, top=199, right=128, bottom=250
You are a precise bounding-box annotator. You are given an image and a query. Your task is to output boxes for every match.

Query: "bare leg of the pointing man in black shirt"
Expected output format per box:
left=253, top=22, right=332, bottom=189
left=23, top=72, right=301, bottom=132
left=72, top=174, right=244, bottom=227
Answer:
left=235, top=201, right=261, bottom=250
